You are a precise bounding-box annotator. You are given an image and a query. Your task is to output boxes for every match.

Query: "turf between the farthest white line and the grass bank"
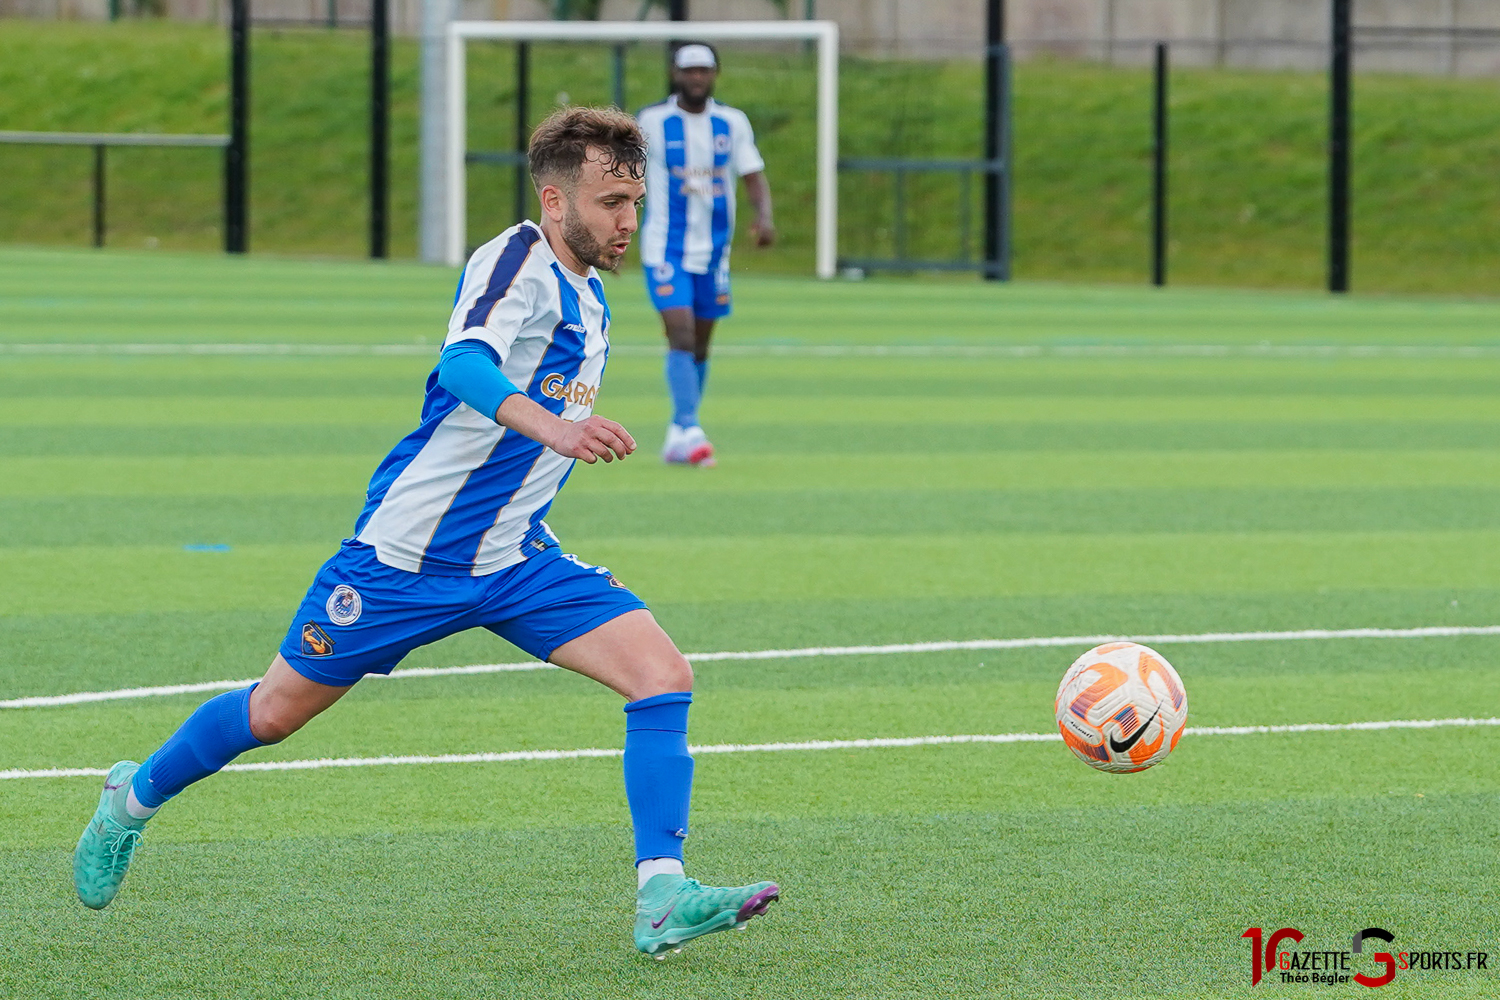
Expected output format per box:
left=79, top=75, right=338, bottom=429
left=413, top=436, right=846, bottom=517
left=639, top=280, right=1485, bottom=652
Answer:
left=0, top=247, right=1500, bottom=343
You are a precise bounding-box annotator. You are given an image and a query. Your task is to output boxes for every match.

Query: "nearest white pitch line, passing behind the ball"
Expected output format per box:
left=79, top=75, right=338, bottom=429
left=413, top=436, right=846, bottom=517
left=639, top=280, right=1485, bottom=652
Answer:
left=0, top=718, right=1500, bottom=781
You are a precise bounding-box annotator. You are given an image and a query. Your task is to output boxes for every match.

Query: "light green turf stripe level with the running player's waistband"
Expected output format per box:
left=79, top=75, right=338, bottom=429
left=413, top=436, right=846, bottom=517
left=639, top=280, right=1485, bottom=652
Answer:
left=0, top=531, right=1500, bottom=615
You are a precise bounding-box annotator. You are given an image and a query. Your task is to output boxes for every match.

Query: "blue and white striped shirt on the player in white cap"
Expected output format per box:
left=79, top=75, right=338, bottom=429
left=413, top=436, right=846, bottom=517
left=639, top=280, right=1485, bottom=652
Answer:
left=636, top=96, right=765, bottom=274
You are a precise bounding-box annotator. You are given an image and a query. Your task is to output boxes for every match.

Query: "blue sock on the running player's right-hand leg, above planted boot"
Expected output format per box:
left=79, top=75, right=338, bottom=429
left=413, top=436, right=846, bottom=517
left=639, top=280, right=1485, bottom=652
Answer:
left=626, top=692, right=693, bottom=865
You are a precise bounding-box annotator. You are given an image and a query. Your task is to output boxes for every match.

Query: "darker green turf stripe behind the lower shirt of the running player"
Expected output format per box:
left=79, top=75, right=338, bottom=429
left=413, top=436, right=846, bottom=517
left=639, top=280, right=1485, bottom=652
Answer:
left=14, top=486, right=1500, bottom=547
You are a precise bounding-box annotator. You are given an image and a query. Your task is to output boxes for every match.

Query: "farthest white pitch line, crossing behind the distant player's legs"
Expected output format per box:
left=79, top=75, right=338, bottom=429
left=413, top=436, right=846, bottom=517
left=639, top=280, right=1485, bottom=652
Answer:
left=0, top=343, right=1500, bottom=358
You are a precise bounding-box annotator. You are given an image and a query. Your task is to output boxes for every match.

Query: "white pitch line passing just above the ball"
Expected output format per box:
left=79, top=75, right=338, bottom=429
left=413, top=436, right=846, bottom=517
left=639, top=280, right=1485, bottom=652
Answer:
left=0, top=625, right=1500, bottom=709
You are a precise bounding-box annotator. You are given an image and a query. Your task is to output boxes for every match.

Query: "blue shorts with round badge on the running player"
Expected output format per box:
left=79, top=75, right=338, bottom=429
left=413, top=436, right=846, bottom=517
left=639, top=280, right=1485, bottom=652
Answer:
left=281, top=541, right=645, bottom=687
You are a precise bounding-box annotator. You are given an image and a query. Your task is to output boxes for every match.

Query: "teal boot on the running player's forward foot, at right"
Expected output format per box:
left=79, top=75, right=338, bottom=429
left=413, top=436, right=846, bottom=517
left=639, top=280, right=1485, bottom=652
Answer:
left=636, top=874, right=782, bottom=960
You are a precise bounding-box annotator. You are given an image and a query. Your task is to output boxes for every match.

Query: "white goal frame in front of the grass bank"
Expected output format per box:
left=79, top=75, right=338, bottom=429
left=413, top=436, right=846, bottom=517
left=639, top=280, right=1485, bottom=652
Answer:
left=444, top=21, right=839, bottom=277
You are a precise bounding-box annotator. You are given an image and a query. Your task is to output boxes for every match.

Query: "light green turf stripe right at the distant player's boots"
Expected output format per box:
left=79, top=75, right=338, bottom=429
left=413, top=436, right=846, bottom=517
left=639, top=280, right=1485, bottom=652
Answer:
left=0, top=442, right=1500, bottom=505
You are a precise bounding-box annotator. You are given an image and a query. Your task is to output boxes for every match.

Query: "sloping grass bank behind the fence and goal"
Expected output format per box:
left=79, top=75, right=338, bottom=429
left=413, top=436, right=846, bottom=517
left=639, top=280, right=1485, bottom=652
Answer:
left=0, top=21, right=1500, bottom=294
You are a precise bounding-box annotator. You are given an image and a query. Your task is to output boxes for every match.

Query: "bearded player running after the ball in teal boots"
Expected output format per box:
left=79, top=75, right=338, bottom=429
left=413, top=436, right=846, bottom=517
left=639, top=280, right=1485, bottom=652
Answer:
left=74, top=108, right=779, bottom=958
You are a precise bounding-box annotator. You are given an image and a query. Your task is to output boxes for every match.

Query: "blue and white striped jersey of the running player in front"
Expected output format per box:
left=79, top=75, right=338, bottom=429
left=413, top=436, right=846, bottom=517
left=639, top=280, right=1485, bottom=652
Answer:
left=354, top=222, right=609, bottom=576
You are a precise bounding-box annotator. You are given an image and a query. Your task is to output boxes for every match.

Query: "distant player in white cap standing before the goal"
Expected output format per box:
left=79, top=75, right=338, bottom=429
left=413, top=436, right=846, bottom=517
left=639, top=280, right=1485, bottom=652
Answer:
left=639, top=42, right=776, bottom=466
